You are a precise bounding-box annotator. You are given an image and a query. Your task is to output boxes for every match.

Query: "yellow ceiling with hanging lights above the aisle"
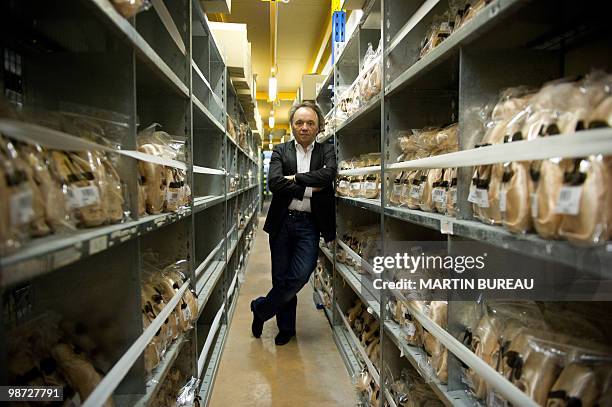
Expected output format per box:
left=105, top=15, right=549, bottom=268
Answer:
left=209, top=0, right=331, bottom=134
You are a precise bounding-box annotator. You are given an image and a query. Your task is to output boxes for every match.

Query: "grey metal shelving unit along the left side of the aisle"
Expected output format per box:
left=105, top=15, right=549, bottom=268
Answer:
left=0, top=0, right=260, bottom=406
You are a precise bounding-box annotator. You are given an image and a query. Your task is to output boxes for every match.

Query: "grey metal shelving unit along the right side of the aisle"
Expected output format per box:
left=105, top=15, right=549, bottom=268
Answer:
left=315, top=0, right=612, bottom=406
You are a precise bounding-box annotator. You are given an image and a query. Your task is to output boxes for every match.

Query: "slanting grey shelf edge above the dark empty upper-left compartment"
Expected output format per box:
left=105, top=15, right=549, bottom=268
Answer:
left=87, top=0, right=189, bottom=98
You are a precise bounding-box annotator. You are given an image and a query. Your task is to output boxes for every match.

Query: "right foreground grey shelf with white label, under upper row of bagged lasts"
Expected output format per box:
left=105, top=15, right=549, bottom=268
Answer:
left=384, top=207, right=612, bottom=278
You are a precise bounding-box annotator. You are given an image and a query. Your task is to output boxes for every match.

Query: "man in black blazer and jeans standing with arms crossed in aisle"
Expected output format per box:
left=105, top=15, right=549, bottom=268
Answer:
left=251, top=102, right=336, bottom=345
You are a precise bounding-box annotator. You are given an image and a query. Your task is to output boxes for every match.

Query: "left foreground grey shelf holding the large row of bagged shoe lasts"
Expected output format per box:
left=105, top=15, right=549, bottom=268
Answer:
left=0, top=209, right=191, bottom=288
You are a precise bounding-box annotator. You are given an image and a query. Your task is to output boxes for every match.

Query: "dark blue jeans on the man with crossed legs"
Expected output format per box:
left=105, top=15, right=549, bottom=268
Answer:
left=254, top=212, right=319, bottom=333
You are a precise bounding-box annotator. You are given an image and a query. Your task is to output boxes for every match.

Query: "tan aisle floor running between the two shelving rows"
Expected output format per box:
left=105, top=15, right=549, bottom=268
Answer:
left=210, top=209, right=356, bottom=407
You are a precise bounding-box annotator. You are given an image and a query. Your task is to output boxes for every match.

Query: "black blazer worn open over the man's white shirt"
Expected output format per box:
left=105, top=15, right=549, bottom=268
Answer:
left=264, top=140, right=336, bottom=242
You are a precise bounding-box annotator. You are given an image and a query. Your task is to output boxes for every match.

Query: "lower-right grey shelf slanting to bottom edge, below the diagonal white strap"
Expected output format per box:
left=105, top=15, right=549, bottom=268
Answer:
left=385, top=321, right=480, bottom=407
